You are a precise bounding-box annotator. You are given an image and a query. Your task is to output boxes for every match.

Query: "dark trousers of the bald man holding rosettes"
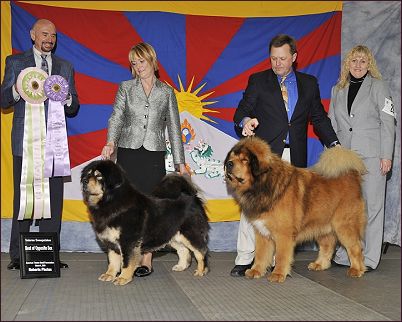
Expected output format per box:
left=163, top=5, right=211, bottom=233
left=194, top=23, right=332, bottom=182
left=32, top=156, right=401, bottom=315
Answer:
left=10, top=156, right=64, bottom=260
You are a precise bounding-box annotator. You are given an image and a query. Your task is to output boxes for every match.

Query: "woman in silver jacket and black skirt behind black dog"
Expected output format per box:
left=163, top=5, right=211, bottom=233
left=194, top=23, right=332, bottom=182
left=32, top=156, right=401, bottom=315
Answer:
left=102, top=43, right=187, bottom=276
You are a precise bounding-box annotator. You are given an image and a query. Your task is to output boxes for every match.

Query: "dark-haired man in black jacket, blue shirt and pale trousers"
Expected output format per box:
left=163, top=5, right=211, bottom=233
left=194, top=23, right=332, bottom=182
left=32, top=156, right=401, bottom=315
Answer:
left=230, top=35, right=339, bottom=276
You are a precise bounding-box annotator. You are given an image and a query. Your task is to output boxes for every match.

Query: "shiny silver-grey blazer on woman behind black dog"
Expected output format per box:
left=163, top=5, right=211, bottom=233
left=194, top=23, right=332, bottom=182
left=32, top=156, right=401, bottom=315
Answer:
left=107, top=78, right=184, bottom=164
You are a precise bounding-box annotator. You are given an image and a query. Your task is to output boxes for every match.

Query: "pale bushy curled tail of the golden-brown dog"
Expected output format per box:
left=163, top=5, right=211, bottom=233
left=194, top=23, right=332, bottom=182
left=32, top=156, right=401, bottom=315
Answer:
left=312, top=146, right=367, bottom=178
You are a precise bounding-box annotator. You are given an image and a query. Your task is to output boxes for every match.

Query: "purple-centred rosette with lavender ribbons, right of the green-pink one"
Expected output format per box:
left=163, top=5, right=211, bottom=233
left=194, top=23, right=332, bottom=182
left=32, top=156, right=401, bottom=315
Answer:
left=43, top=75, right=71, bottom=178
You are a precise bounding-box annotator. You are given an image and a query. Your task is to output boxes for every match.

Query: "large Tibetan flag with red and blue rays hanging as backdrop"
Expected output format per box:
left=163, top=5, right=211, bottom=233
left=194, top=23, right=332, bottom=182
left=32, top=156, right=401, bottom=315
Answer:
left=1, top=1, right=342, bottom=222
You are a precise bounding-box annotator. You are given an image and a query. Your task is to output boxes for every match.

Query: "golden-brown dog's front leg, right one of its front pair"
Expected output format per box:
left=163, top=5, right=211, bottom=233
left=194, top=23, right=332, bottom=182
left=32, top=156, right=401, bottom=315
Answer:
left=268, top=235, right=295, bottom=283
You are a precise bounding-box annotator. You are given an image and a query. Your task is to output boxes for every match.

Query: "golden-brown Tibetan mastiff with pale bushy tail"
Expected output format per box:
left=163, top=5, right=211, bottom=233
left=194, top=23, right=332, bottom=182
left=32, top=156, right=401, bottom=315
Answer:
left=224, top=137, right=366, bottom=282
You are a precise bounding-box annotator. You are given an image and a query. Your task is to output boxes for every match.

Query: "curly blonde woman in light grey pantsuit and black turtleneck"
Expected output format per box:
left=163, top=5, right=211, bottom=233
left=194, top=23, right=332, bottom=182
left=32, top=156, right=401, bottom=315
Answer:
left=329, top=45, right=395, bottom=271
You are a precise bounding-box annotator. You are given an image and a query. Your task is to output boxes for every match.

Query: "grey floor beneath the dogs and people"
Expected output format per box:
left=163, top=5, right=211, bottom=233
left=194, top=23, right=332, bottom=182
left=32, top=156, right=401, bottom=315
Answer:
left=1, top=246, right=401, bottom=321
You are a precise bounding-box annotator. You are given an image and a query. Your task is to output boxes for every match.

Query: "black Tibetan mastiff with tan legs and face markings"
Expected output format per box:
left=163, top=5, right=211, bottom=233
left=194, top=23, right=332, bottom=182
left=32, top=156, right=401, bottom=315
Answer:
left=81, top=160, right=209, bottom=285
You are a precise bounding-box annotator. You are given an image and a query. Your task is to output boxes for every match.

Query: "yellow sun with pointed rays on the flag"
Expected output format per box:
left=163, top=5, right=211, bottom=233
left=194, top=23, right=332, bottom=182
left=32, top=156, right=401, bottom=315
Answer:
left=167, top=76, right=219, bottom=123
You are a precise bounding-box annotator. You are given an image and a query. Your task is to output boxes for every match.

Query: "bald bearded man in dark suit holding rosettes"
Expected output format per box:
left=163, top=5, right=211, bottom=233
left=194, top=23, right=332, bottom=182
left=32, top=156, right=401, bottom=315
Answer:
left=1, top=19, right=79, bottom=270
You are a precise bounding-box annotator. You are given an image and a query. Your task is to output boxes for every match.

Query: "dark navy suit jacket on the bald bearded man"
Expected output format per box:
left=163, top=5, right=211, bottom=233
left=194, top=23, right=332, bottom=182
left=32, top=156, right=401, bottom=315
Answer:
left=1, top=49, right=79, bottom=156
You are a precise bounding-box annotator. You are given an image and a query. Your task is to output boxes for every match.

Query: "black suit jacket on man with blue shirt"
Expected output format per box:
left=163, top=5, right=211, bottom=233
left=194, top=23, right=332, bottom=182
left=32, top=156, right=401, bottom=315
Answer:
left=233, top=69, right=338, bottom=167
